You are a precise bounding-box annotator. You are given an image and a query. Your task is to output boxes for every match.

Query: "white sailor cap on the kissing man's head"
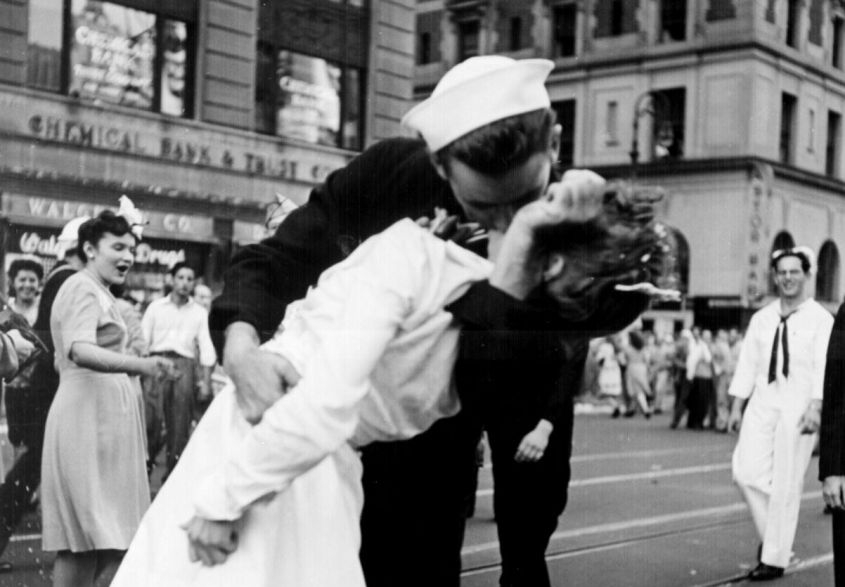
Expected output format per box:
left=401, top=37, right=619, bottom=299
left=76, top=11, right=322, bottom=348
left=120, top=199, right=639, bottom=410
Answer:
left=402, top=55, right=554, bottom=152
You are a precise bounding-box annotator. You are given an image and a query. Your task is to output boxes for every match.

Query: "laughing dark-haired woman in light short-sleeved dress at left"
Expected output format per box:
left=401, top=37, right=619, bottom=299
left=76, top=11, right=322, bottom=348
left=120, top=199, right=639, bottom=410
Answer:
left=41, top=211, right=172, bottom=587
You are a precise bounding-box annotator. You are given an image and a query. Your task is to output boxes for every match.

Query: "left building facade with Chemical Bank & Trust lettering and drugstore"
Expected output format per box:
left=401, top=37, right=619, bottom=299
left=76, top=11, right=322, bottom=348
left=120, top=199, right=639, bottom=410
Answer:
left=0, top=0, right=414, bottom=299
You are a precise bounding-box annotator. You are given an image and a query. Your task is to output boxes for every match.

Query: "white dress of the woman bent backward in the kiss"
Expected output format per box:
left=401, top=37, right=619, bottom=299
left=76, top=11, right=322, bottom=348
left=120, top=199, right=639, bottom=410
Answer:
left=112, top=220, right=492, bottom=587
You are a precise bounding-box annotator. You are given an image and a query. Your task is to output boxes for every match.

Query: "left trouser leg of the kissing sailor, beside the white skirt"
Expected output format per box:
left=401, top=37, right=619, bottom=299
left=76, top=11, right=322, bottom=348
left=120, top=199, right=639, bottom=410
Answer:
left=361, top=411, right=480, bottom=587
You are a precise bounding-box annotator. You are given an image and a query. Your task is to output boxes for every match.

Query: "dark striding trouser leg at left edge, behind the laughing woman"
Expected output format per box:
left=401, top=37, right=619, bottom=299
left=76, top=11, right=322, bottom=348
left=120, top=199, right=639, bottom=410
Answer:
left=0, top=444, right=41, bottom=553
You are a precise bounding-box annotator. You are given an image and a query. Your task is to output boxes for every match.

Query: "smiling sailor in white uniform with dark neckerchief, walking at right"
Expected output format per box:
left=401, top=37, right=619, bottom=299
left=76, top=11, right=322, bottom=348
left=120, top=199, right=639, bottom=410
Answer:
left=728, top=247, right=833, bottom=581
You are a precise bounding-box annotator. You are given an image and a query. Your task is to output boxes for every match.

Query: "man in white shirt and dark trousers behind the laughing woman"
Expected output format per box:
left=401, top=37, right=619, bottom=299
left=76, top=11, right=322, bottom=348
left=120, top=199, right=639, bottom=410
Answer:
left=141, top=263, right=217, bottom=474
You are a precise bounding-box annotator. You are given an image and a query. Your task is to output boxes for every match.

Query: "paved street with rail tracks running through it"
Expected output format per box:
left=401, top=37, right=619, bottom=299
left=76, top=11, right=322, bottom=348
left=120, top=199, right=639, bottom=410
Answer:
left=0, top=415, right=833, bottom=587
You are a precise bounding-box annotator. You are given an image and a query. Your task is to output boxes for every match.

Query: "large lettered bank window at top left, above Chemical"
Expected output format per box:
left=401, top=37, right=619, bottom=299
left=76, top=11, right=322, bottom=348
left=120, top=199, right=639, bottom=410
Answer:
left=26, top=0, right=195, bottom=116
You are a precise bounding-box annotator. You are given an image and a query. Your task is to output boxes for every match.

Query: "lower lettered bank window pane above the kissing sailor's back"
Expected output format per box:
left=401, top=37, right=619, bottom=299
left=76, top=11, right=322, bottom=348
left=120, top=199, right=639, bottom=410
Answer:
left=255, top=43, right=364, bottom=150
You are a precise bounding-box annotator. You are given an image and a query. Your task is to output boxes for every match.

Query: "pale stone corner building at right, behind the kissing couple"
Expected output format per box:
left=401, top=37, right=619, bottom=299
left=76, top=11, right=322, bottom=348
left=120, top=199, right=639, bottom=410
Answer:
left=415, top=0, right=845, bottom=330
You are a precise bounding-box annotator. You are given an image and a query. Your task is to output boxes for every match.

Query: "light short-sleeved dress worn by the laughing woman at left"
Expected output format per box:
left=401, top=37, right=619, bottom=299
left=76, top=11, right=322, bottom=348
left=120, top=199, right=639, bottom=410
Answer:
left=41, top=270, right=150, bottom=552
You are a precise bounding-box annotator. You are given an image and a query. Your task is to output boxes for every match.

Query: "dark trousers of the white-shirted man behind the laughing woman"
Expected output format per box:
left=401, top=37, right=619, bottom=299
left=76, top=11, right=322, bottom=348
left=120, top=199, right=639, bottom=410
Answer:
left=144, top=353, right=197, bottom=473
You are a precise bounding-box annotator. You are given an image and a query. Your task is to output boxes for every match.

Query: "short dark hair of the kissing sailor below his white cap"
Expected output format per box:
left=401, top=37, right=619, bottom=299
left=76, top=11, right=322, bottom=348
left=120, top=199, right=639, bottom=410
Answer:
left=435, top=108, right=556, bottom=175
